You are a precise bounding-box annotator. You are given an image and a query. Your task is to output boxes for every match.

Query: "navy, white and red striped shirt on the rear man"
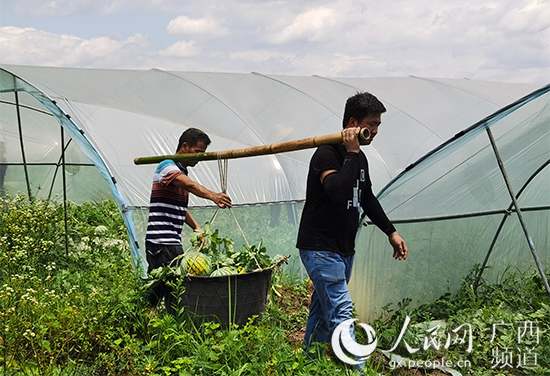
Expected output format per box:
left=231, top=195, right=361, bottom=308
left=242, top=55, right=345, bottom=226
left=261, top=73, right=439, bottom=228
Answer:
left=145, top=159, right=189, bottom=245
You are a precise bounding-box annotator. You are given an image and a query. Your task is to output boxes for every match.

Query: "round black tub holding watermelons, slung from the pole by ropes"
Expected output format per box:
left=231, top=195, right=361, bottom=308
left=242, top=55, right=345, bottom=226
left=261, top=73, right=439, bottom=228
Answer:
left=166, top=269, right=272, bottom=327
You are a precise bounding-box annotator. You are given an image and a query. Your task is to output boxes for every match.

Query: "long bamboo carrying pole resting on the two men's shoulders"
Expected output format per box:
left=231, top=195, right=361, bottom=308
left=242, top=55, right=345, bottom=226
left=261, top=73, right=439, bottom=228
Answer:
left=134, top=128, right=371, bottom=165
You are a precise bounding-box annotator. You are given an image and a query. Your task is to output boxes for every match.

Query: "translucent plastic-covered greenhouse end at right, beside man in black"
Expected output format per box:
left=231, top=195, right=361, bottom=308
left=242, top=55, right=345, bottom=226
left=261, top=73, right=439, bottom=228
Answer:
left=353, top=86, right=550, bottom=318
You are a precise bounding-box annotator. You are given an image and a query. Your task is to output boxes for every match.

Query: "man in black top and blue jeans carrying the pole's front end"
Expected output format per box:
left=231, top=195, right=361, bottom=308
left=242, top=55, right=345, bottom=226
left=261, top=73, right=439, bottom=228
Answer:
left=296, top=93, right=408, bottom=362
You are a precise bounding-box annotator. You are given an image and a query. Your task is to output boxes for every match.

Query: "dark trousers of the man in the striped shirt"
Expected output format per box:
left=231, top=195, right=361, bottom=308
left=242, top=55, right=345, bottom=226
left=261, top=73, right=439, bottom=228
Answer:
left=145, top=242, right=183, bottom=306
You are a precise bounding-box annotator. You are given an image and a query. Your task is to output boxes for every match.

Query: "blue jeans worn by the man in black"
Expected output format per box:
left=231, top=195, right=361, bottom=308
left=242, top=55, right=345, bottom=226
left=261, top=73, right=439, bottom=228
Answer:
left=300, top=249, right=354, bottom=349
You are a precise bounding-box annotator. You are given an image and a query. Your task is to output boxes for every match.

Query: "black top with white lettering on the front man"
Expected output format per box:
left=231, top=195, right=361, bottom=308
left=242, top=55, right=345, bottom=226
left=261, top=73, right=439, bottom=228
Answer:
left=296, top=144, right=395, bottom=256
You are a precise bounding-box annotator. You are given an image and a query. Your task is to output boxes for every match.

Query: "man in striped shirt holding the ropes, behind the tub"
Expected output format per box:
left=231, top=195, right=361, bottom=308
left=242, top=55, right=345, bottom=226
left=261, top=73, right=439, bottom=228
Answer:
left=145, top=128, right=231, bottom=305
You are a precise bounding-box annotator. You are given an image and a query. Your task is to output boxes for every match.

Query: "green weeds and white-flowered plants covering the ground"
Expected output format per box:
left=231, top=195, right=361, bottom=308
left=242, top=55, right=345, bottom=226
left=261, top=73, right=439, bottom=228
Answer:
left=0, top=196, right=550, bottom=376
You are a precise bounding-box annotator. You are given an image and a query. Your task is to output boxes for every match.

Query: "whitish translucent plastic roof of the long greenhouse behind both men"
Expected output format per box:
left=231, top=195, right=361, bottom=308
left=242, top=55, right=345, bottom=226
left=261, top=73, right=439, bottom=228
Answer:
left=3, top=66, right=535, bottom=206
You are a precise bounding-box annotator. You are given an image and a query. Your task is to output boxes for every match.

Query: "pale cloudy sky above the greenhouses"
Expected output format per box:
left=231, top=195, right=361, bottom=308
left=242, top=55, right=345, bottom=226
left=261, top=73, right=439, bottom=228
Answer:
left=0, top=0, right=550, bottom=86
